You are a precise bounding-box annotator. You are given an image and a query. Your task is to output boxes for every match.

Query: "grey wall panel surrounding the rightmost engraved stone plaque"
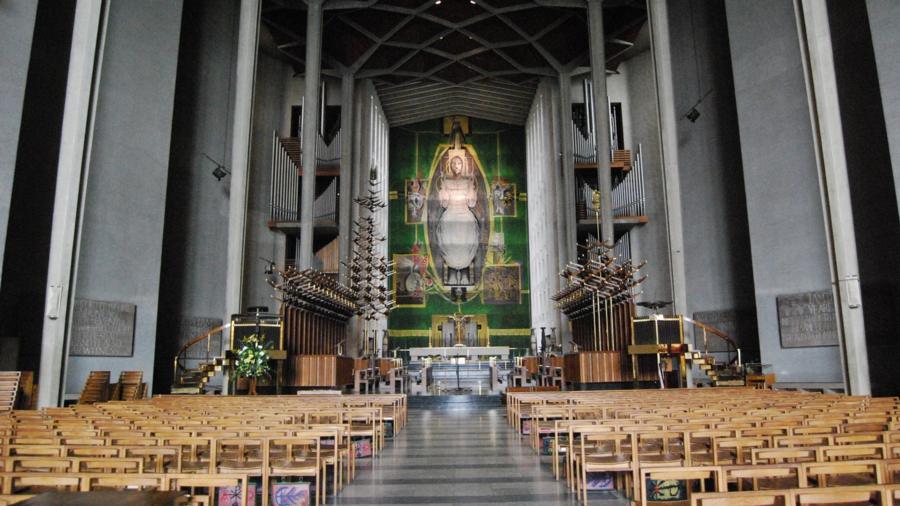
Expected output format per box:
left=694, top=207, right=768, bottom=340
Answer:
left=725, top=0, right=842, bottom=382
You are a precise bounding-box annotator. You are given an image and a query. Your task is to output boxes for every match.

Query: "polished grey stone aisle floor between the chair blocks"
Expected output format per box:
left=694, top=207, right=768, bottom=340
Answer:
left=330, top=406, right=627, bottom=506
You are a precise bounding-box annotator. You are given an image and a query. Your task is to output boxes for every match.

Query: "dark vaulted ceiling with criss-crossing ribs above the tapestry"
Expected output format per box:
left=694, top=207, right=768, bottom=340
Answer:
left=263, top=0, right=647, bottom=125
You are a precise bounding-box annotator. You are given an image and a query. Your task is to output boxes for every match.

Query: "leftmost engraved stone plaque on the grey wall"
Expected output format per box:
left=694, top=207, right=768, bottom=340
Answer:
left=69, top=298, right=137, bottom=357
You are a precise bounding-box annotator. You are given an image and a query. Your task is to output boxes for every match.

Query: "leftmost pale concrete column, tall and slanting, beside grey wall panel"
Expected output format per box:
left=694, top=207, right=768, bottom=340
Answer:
left=38, top=0, right=106, bottom=407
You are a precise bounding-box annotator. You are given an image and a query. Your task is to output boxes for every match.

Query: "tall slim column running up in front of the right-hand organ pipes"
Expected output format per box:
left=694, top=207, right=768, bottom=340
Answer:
left=588, top=0, right=616, bottom=246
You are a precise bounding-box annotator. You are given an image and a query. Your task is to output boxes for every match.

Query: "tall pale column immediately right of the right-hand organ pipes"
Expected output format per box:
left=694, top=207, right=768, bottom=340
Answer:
left=647, top=0, right=687, bottom=314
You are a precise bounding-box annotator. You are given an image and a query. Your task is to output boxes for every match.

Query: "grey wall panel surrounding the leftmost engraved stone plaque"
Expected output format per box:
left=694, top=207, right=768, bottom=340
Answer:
left=65, top=0, right=182, bottom=393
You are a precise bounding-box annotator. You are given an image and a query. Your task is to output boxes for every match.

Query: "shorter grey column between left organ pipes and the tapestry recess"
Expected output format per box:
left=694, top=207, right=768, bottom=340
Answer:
left=338, top=73, right=355, bottom=283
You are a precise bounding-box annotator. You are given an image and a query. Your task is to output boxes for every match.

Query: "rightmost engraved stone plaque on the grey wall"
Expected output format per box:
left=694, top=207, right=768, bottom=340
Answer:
left=776, top=290, right=838, bottom=348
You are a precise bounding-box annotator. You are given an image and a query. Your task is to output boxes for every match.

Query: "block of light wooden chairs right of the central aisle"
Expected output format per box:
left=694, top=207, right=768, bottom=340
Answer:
left=507, top=389, right=900, bottom=502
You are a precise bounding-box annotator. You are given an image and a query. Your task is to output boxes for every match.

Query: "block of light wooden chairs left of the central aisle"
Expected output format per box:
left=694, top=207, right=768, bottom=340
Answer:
left=0, top=395, right=406, bottom=504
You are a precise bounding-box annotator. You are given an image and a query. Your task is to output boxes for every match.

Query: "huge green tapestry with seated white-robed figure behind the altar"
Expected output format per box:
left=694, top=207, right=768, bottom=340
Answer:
left=388, top=117, right=531, bottom=355
